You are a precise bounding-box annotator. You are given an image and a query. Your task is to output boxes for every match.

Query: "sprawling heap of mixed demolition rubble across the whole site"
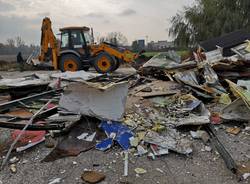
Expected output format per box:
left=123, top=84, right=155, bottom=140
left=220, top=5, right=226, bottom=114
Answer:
left=0, top=34, right=250, bottom=184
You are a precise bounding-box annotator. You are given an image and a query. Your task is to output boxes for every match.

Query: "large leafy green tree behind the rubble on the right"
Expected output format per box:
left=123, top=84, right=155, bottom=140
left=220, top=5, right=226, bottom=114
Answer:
left=169, top=0, right=250, bottom=47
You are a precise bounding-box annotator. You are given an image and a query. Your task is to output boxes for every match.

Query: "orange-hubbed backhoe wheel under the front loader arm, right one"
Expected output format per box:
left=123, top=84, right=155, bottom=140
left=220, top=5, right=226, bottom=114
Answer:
left=93, top=52, right=115, bottom=73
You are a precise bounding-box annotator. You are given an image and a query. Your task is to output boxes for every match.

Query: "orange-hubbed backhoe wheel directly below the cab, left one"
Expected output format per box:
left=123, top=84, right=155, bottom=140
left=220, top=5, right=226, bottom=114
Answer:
left=60, top=54, right=81, bottom=72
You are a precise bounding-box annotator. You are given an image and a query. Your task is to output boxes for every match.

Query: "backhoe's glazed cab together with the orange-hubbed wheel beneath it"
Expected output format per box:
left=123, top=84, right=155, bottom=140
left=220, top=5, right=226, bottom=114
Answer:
left=59, top=27, right=92, bottom=71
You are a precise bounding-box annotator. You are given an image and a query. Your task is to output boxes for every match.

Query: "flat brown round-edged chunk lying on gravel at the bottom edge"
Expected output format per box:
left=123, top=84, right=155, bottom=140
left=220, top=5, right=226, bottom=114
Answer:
left=81, top=171, right=105, bottom=183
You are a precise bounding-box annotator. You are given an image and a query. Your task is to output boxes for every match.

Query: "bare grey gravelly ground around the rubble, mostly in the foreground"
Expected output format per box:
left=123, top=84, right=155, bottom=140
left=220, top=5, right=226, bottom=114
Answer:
left=0, top=68, right=250, bottom=184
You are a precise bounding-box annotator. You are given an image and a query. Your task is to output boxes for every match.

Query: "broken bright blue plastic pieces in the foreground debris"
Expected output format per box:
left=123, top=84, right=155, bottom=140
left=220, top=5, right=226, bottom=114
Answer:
left=96, top=121, right=133, bottom=151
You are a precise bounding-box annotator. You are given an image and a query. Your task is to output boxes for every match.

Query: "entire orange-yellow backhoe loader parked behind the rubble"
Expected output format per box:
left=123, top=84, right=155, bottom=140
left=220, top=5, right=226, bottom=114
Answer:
left=38, top=17, right=139, bottom=73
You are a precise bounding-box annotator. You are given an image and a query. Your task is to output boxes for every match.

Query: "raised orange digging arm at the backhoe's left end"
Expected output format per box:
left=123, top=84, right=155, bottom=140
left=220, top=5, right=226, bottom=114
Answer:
left=38, top=17, right=58, bottom=70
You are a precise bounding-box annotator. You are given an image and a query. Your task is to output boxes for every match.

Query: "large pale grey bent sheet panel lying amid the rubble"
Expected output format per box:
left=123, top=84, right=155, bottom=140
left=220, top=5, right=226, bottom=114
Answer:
left=59, top=82, right=128, bottom=121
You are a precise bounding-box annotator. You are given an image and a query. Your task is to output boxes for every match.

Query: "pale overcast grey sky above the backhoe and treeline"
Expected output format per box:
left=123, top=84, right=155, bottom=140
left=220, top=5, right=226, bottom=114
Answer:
left=0, top=0, right=194, bottom=44
